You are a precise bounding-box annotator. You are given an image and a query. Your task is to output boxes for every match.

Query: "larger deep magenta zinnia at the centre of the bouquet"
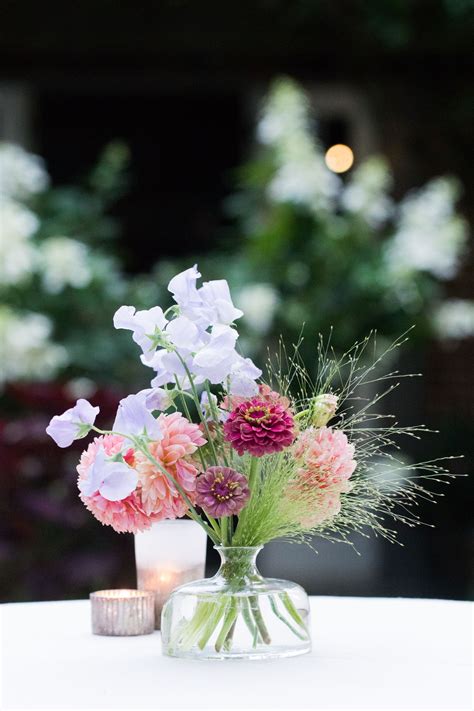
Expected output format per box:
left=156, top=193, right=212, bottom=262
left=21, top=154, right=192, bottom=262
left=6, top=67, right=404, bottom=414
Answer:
left=224, top=397, right=295, bottom=457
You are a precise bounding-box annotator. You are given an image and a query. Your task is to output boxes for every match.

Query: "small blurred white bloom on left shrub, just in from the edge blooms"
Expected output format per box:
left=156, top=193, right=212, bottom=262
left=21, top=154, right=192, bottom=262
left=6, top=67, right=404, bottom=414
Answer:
left=39, top=237, right=92, bottom=294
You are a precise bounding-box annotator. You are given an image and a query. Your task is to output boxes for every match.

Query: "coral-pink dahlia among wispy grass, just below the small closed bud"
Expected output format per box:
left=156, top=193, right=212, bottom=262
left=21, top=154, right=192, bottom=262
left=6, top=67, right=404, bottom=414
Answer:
left=295, top=427, right=357, bottom=489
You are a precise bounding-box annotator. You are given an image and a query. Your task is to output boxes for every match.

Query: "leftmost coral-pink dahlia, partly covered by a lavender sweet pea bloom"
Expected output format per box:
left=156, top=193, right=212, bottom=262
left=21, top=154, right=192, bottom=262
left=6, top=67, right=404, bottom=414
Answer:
left=77, top=435, right=159, bottom=533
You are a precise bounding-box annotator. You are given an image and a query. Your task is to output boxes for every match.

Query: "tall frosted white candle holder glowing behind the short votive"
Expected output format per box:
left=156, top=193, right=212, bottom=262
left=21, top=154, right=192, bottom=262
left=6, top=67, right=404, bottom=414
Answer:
left=135, top=519, right=207, bottom=629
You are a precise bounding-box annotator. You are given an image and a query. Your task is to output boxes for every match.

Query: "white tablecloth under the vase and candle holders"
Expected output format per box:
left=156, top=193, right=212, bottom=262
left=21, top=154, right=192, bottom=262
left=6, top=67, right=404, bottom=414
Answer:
left=1, top=597, right=472, bottom=709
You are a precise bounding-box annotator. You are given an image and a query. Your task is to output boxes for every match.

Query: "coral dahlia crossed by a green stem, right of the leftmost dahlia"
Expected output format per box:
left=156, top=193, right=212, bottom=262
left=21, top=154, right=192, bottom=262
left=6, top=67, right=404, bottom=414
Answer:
left=134, top=412, right=206, bottom=519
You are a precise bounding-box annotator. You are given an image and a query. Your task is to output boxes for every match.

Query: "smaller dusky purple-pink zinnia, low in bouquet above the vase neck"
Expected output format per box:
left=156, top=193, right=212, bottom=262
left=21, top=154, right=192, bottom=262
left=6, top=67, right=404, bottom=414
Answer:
left=196, top=467, right=250, bottom=518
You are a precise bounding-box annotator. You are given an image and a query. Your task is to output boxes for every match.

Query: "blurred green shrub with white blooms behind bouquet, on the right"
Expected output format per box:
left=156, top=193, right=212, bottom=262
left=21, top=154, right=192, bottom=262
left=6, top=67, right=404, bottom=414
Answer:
left=158, top=79, right=474, bottom=368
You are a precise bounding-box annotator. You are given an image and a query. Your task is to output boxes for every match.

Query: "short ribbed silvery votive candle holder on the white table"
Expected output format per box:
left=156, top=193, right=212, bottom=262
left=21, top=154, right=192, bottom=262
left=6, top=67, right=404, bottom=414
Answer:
left=90, top=590, right=155, bottom=636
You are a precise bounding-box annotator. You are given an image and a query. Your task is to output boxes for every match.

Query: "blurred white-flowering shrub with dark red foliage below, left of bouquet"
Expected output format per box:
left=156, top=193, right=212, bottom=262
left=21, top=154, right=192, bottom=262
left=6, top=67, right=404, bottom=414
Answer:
left=0, top=143, right=157, bottom=600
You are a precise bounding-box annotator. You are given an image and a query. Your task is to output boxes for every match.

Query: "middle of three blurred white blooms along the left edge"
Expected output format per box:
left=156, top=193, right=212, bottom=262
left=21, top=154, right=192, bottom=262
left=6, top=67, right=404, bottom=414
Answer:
left=0, top=195, right=39, bottom=286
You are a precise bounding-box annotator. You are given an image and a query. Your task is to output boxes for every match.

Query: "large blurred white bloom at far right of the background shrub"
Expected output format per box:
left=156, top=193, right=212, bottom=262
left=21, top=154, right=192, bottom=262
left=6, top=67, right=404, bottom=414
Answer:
left=386, top=178, right=468, bottom=279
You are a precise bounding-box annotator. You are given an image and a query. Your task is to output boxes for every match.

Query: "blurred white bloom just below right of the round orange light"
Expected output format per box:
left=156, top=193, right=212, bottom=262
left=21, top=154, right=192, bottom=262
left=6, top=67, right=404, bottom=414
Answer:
left=341, top=156, right=393, bottom=227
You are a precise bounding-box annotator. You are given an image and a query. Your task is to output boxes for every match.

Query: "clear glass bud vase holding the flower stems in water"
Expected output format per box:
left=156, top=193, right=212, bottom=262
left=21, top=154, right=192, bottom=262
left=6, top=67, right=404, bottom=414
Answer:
left=161, top=546, right=311, bottom=659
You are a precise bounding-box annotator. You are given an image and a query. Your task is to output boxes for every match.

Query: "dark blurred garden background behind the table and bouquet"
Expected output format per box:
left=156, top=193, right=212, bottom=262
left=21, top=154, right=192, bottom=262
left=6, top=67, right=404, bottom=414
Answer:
left=0, top=0, right=474, bottom=600
